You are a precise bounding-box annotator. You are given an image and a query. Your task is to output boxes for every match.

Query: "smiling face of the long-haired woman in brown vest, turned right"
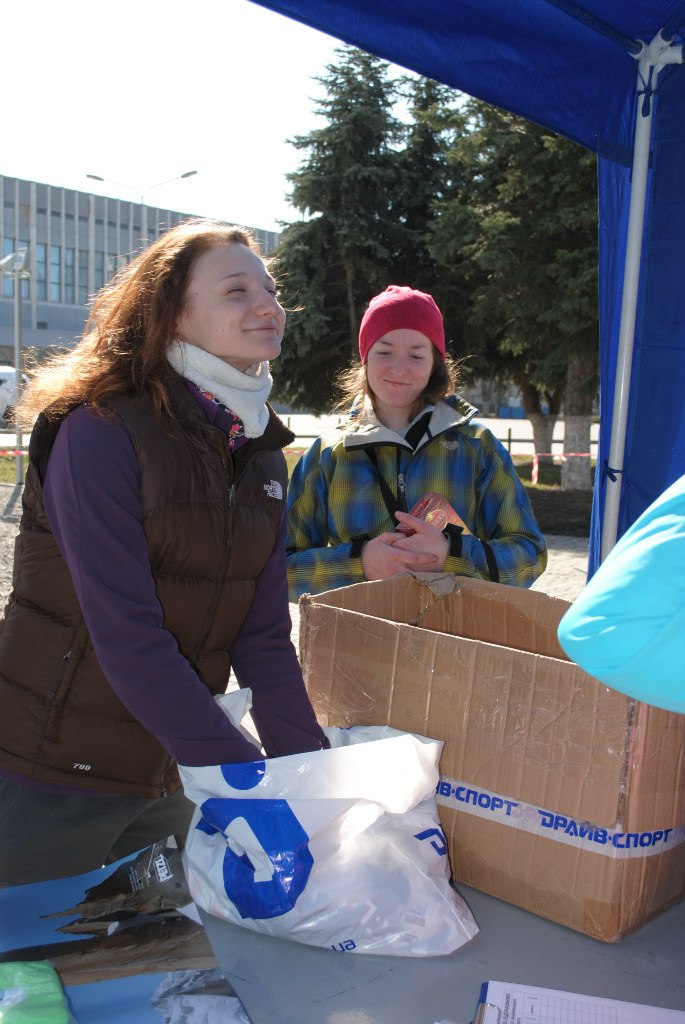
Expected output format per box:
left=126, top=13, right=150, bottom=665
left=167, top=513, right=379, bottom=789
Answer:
left=176, top=243, right=286, bottom=371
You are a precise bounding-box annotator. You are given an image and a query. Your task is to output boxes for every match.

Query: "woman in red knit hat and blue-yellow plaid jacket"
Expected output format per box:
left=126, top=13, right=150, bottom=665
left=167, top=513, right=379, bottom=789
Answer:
left=287, top=285, right=547, bottom=601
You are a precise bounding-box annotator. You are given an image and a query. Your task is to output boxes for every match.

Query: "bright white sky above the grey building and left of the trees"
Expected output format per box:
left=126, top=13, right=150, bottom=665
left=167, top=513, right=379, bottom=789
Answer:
left=0, top=0, right=387, bottom=230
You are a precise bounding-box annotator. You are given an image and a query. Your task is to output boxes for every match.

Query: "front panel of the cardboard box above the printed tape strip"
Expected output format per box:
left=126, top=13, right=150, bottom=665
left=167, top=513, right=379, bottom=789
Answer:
left=300, top=602, right=629, bottom=826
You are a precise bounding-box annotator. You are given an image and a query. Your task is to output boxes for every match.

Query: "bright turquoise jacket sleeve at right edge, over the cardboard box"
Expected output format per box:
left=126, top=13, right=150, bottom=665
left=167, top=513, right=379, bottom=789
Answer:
left=558, top=476, right=685, bottom=714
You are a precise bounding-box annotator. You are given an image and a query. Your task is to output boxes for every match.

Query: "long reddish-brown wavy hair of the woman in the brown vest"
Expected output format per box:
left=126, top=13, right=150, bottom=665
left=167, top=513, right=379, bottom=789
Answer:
left=16, top=217, right=261, bottom=429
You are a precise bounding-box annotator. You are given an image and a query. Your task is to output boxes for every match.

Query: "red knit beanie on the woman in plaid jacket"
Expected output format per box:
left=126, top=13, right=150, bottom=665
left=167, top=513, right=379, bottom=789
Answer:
left=359, top=285, right=444, bottom=362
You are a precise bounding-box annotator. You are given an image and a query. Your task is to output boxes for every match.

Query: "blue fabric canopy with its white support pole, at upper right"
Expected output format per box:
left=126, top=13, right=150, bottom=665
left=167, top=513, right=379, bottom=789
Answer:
left=248, top=0, right=685, bottom=570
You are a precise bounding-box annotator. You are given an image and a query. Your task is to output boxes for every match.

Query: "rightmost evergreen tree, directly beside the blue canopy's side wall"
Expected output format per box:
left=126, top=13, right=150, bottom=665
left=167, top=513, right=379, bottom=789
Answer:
left=433, top=99, right=598, bottom=485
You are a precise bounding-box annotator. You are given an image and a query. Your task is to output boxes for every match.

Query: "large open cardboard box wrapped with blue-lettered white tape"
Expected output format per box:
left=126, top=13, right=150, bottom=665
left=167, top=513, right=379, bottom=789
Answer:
left=300, top=573, right=685, bottom=942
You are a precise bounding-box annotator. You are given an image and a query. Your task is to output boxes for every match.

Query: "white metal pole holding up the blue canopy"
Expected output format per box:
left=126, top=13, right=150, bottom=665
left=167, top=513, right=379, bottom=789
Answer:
left=601, top=34, right=683, bottom=561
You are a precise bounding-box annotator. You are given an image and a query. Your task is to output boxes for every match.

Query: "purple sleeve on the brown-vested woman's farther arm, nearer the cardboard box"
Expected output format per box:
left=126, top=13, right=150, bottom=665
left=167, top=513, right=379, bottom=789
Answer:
left=231, top=502, right=329, bottom=757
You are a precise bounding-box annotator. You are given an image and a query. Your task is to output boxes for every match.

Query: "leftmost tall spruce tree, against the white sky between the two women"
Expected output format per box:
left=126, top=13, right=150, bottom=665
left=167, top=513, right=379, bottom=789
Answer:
left=274, top=46, right=401, bottom=413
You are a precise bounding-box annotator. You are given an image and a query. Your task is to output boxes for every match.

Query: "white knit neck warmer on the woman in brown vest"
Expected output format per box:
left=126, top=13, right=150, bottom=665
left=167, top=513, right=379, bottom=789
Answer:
left=167, top=338, right=273, bottom=437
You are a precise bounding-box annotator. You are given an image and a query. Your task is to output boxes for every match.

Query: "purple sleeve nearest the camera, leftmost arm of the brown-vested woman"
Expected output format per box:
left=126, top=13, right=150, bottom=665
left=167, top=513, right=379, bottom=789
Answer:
left=44, top=407, right=262, bottom=765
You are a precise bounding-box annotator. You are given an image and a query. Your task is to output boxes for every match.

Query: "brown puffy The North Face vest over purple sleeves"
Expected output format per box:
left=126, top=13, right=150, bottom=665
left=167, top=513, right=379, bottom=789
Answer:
left=0, top=378, right=293, bottom=798
